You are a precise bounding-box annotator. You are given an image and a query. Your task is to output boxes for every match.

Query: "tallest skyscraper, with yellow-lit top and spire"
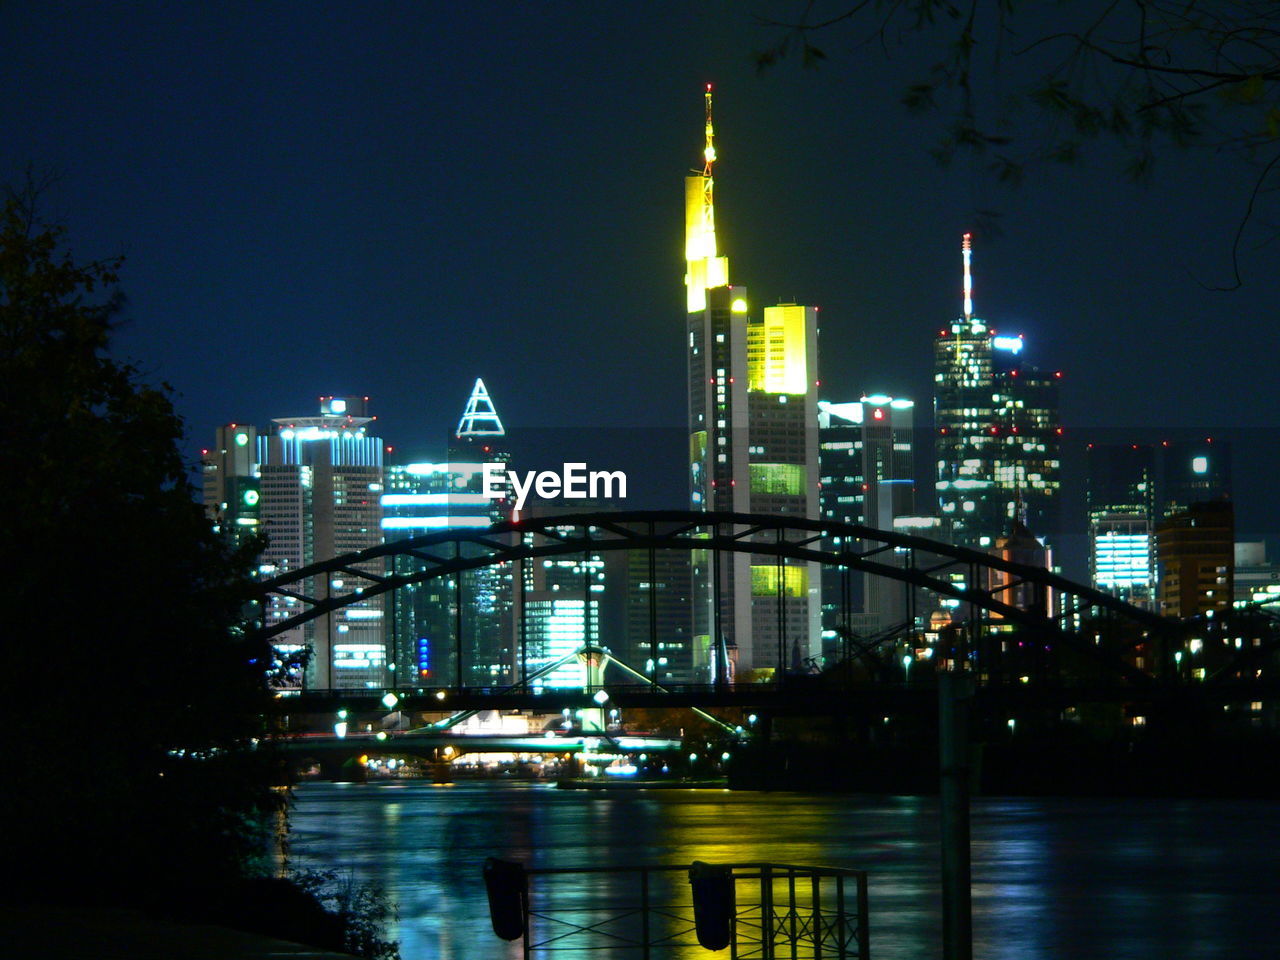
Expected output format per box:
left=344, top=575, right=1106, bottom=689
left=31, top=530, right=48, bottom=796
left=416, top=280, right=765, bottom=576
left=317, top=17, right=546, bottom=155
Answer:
left=685, top=84, right=820, bottom=669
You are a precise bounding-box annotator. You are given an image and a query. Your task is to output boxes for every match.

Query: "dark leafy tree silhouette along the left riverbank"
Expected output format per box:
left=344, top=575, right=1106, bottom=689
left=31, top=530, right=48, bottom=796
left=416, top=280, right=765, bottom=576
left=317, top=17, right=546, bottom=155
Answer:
left=0, top=181, right=279, bottom=900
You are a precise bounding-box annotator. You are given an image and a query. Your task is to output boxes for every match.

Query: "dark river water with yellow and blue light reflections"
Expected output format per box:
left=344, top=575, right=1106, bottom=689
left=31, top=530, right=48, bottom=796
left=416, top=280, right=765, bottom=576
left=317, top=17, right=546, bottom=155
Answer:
left=291, top=781, right=1280, bottom=960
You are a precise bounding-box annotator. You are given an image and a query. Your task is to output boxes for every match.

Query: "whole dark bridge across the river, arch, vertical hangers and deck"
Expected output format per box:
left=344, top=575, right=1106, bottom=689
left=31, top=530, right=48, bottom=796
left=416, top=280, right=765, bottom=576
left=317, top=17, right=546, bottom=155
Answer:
left=259, top=511, right=1276, bottom=712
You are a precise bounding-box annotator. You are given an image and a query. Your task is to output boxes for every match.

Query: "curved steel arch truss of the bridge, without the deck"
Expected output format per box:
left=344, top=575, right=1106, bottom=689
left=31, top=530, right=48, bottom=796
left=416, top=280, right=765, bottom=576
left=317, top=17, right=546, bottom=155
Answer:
left=249, top=511, right=1178, bottom=685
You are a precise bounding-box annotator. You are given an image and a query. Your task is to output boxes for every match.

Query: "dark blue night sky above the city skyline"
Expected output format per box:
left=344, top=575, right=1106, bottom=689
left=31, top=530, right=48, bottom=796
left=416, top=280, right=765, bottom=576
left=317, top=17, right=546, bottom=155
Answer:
left=0, top=3, right=1280, bottom=563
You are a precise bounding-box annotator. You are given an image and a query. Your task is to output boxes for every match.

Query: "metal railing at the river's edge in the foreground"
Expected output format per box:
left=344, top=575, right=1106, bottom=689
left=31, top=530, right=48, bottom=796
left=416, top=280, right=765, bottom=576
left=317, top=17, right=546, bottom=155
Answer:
left=512, top=863, right=870, bottom=960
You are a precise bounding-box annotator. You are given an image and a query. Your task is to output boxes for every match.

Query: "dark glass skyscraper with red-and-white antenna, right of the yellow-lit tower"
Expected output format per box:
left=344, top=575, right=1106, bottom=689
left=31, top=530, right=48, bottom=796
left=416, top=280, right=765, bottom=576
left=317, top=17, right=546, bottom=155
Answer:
left=933, top=234, right=1062, bottom=550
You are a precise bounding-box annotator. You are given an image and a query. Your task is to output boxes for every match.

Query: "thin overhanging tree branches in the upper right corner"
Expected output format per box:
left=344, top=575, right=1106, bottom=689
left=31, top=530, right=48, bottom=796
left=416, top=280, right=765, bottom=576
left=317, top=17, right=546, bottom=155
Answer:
left=756, top=0, right=1280, bottom=287
